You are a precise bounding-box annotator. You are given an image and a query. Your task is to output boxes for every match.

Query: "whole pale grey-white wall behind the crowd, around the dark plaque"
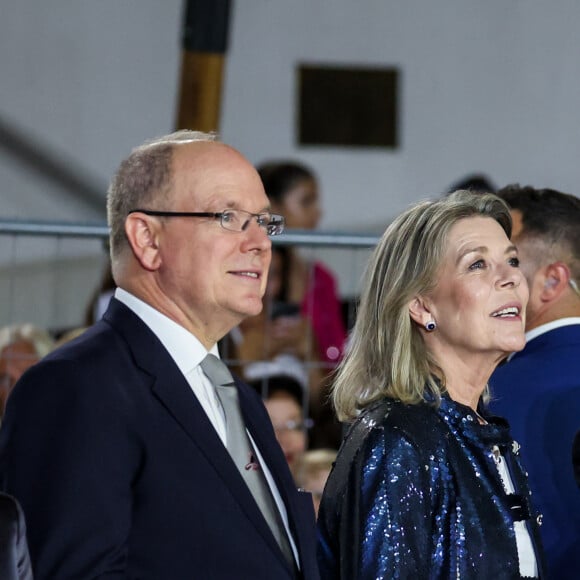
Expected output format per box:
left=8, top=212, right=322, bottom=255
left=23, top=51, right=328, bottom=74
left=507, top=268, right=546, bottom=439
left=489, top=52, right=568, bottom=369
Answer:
left=0, top=0, right=580, bottom=326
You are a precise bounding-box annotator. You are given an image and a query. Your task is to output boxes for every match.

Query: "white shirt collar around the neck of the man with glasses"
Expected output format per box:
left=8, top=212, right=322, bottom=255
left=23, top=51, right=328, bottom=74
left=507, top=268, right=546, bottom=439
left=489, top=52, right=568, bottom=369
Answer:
left=115, top=288, right=219, bottom=375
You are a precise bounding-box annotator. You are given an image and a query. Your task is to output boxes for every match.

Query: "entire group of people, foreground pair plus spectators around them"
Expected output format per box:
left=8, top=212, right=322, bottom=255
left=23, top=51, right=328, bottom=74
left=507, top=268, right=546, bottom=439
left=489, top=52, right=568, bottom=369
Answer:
left=0, top=131, right=580, bottom=580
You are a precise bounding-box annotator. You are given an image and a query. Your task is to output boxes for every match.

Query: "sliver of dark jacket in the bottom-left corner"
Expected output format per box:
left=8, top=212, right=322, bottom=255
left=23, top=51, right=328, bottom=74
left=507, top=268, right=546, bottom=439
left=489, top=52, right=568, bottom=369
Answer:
left=0, top=493, right=32, bottom=580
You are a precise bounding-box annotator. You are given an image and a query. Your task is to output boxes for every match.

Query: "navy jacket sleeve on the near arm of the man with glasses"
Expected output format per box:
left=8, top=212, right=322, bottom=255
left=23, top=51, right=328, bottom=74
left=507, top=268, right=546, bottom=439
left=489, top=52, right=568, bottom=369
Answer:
left=0, top=360, right=140, bottom=580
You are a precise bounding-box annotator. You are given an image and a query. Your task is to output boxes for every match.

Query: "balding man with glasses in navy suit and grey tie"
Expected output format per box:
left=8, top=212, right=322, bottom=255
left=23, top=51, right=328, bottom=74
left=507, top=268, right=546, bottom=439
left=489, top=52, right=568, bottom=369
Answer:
left=0, top=131, right=318, bottom=580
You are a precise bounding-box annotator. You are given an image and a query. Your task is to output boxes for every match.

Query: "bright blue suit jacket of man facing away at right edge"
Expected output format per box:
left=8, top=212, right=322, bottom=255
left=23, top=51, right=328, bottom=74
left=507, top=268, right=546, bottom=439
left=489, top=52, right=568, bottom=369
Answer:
left=490, top=325, right=580, bottom=580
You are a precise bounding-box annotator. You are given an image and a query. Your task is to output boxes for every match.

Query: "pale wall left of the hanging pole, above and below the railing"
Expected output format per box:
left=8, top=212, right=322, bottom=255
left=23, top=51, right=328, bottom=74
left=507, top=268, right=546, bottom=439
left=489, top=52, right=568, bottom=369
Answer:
left=0, top=0, right=181, bottom=329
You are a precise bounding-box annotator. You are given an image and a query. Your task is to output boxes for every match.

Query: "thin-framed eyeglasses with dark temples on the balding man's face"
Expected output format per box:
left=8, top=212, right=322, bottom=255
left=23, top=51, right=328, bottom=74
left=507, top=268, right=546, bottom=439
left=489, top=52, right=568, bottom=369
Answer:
left=129, top=209, right=284, bottom=236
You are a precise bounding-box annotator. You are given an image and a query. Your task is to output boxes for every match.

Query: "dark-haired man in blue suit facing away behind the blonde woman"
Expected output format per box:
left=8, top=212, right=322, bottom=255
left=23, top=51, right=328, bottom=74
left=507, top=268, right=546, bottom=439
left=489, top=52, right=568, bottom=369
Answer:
left=490, top=186, right=580, bottom=580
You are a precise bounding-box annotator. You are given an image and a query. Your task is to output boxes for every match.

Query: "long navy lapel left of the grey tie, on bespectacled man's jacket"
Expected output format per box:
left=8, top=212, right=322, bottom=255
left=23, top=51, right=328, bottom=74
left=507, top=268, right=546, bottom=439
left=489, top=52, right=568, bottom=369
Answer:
left=104, top=299, right=287, bottom=561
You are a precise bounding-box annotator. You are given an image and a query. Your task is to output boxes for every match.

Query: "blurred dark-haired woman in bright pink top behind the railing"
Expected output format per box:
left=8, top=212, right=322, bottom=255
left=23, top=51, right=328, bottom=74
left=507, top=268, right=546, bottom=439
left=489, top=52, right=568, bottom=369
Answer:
left=258, top=160, right=346, bottom=447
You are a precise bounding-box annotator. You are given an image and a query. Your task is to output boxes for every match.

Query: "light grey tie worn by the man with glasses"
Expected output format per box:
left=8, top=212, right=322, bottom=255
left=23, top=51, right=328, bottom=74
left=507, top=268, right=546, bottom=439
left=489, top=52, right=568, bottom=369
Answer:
left=201, top=354, right=295, bottom=568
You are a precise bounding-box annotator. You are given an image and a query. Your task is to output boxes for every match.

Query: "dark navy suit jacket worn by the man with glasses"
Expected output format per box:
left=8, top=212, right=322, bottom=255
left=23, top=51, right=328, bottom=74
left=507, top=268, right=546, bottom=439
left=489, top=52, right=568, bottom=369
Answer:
left=0, top=300, right=318, bottom=580
